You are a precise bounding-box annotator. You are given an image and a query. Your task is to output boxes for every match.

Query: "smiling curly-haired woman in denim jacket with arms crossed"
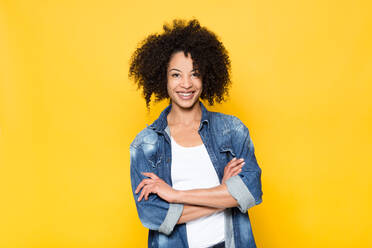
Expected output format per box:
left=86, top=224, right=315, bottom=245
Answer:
left=129, top=20, right=262, bottom=248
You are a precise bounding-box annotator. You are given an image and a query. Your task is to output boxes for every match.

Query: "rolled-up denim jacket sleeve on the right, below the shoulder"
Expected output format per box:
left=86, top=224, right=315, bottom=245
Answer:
left=225, top=118, right=263, bottom=213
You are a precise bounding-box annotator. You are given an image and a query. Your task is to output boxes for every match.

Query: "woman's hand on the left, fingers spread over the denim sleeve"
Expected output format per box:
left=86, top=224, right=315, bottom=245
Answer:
left=135, top=172, right=178, bottom=203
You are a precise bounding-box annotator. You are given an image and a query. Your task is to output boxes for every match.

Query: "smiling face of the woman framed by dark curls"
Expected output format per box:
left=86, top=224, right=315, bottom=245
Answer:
left=167, top=51, right=202, bottom=109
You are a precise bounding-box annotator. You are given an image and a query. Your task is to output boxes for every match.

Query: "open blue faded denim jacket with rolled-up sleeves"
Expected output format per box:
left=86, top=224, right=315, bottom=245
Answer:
left=130, top=102, right=262, bottom=248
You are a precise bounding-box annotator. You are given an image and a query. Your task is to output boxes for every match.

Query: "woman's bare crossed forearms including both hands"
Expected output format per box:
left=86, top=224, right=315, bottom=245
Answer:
left=135, top=158, right=245, bottom=224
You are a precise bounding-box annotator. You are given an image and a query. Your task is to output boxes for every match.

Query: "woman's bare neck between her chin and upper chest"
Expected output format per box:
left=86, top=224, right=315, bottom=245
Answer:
left=167, top=102, right=202, bottom=125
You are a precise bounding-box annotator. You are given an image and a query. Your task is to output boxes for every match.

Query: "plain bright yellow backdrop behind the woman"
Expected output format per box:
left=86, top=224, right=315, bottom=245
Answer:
left=0, top=0, right=372, bottom=248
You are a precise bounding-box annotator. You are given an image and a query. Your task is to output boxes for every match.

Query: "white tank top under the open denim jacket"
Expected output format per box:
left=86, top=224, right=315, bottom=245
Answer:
left=171, top=137, right=225, bottom=248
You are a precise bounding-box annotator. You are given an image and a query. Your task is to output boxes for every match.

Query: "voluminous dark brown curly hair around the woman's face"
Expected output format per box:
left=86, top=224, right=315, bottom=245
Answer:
left=128, top=19, right=231, bottom=108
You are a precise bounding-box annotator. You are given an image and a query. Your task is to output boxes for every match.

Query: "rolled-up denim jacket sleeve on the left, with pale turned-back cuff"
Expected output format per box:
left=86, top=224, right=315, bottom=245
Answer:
left=130, top=146, right=183, bottom=235
